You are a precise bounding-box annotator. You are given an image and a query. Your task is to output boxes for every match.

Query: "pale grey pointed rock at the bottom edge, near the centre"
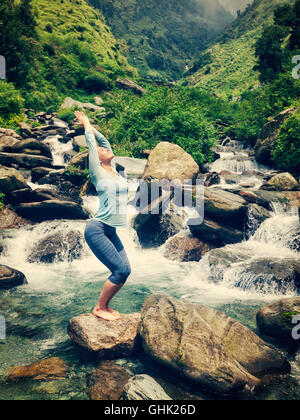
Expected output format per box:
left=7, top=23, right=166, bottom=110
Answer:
left=123, top=375, right=172, bottom=401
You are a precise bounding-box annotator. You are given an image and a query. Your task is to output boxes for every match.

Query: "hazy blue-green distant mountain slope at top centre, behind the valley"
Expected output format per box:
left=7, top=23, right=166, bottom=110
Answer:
left=90, top=0, right=233, bottom=80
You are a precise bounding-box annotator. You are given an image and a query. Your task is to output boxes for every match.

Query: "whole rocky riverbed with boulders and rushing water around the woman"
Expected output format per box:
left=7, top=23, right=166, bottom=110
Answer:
left=0, top=109, right=300, bottom=399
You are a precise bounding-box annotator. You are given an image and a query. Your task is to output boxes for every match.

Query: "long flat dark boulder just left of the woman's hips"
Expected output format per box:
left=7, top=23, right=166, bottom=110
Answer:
left=16, top=200, right=90, bottom=222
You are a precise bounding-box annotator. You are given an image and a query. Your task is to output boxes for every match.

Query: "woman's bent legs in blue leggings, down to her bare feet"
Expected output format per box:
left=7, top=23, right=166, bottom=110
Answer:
left=85, top=221, right=129, bottom=321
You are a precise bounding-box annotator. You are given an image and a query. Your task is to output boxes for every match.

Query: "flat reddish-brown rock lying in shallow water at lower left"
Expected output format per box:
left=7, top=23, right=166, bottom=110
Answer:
left=7, top=357, right=67, bottom=382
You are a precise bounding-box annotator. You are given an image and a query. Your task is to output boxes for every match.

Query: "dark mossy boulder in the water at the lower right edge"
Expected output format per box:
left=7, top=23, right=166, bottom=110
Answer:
left=256, top=297, right=300, bottom=345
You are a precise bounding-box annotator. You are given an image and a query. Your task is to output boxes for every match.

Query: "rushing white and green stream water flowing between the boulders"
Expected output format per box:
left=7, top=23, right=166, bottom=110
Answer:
left=0, top=137, right=300, bottom=400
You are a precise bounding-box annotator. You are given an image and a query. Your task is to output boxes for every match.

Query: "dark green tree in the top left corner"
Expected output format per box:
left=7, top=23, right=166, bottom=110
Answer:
left=0, top=0, right=40, bottom=87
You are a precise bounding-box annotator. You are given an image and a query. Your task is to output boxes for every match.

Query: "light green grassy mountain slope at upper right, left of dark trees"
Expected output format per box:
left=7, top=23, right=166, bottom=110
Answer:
left=180, top=0, right=293, bottom=97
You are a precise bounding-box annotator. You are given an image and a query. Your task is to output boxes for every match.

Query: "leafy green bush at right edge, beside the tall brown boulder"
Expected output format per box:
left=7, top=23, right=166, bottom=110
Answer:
left=272, top=111, right=300, bottom=174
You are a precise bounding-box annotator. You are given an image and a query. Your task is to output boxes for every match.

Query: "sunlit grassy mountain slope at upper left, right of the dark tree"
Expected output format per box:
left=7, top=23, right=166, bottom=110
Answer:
left=9, top=0, right=137, bottom=111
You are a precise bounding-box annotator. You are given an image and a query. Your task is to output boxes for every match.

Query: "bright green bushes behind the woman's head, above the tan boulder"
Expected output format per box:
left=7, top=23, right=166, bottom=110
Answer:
left=88, top=85, right=238, bottom=164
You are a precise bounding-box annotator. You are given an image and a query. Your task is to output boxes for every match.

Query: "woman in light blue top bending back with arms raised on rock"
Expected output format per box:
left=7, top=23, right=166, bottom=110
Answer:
left=75, top=111, right=131, bottom=321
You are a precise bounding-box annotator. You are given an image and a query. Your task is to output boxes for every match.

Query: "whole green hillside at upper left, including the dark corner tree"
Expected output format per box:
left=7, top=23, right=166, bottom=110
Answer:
left=0, top=0, right=136, bottom=116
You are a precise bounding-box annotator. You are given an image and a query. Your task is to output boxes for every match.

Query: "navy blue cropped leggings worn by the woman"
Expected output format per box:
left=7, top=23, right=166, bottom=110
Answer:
left=84, top=219, right=131, bottom=285
